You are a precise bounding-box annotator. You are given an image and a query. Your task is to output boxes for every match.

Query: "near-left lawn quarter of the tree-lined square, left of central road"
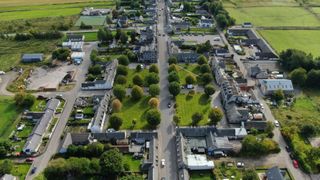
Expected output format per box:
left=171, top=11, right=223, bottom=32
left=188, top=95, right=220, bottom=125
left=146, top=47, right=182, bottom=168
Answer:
left=115, top=96, right=150, bottom=129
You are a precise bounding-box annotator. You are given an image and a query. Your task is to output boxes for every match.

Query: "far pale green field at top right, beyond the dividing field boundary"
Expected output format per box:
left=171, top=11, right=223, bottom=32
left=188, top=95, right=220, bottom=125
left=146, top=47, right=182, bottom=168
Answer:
left=226, top=7, right=320, bottom=27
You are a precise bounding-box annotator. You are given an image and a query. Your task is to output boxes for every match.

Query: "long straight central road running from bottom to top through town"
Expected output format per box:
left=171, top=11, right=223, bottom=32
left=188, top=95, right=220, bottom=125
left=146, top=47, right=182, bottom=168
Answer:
left=157, top=0, right=178, bottom=180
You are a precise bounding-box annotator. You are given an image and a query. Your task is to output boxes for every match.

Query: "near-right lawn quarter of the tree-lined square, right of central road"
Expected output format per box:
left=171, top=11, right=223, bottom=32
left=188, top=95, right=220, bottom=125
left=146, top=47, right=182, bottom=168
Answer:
left=176, top=93, right=211, bottom=126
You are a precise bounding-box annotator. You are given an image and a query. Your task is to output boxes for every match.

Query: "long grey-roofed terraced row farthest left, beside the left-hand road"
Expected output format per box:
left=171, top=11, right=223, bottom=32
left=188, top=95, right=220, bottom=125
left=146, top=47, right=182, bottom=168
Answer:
left=23, top=99, right=60, bottom=155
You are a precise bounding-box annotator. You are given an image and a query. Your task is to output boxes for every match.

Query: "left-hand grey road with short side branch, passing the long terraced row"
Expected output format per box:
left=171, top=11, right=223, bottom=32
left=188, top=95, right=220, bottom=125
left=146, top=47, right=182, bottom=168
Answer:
left=26, top=43, right=97, bottom=180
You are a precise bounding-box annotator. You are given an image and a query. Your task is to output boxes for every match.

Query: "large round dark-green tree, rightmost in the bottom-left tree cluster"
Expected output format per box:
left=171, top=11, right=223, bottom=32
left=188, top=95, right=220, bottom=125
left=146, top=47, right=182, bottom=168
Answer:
left=100, top=148, right=123, bottom=176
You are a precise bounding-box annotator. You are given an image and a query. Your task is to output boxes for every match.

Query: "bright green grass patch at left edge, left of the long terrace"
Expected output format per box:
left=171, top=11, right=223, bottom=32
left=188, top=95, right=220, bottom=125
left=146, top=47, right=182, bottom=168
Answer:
left=0, top=96, right=20, bottom=139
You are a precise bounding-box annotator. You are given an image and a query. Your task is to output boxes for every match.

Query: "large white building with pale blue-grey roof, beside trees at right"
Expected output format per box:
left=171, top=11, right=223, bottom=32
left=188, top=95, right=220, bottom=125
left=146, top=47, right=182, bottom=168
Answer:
left=260, top=79, right=294, bottom=95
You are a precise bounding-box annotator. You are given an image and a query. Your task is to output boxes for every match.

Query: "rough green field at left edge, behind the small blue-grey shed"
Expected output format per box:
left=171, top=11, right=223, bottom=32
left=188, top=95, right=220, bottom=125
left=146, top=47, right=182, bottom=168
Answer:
left=0, top=40, right=61, bottom=71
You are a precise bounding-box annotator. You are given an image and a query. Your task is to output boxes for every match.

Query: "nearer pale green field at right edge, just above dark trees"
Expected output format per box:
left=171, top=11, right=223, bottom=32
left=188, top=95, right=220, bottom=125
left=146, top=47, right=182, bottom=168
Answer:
left=259, top=30, right=320, bottom=56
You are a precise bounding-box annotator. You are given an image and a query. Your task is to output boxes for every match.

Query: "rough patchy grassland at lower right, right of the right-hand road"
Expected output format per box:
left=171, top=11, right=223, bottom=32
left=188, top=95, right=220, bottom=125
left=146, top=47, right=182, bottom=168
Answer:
left=271, top=90, right=320, bottom=173
